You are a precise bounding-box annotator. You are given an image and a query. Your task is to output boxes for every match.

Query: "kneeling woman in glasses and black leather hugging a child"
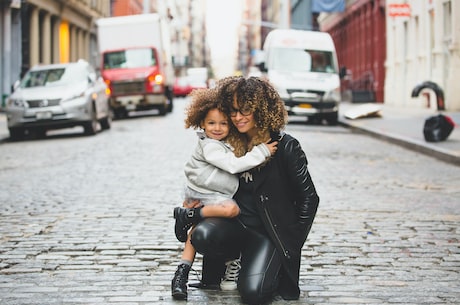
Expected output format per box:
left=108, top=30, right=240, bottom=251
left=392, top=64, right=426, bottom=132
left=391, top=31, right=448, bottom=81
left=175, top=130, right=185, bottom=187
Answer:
left=191, top=77, right=319, bottom=304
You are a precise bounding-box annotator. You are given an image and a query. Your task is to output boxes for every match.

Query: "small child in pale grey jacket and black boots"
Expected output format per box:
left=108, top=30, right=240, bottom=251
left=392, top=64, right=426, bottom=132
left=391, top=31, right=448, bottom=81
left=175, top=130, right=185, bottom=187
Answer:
left=171, top=89, right=277, bottom=300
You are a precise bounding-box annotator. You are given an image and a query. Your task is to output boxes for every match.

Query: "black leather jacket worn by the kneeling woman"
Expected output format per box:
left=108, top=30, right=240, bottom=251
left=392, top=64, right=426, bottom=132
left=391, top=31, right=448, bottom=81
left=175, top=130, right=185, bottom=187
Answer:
left=250, top=133, right=319, bottom=299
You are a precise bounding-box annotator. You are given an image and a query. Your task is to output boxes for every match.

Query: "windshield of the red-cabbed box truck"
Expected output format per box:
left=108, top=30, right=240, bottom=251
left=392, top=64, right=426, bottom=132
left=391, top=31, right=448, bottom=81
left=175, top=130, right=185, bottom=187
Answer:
left=104, top=48, right=156, bottom=69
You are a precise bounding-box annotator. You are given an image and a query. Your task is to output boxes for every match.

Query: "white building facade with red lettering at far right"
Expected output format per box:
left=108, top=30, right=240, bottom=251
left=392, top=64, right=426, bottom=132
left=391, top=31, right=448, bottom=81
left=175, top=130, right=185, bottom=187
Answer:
left=385, top=0, right=460, bottom=111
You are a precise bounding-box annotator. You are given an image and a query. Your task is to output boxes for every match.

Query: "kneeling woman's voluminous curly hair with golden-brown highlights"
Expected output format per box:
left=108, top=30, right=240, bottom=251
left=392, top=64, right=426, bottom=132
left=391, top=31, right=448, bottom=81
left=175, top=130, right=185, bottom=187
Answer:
left=215, top=76, right=288, bottom=156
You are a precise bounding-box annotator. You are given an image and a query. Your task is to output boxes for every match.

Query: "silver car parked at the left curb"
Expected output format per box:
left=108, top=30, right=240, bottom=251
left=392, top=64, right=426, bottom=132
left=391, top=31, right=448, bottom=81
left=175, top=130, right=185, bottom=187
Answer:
left=5, top=60, right=112, bottom=139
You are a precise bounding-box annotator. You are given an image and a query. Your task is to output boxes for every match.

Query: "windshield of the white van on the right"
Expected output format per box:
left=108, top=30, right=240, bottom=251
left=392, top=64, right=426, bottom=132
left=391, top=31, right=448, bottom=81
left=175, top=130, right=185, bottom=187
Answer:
left=268, top=48, right=337, bottom=73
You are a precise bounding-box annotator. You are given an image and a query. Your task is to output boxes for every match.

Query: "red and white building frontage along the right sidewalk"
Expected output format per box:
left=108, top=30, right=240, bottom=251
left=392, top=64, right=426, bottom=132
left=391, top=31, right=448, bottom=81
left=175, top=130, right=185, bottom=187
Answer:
left=319, top=0, right=460, bottom=110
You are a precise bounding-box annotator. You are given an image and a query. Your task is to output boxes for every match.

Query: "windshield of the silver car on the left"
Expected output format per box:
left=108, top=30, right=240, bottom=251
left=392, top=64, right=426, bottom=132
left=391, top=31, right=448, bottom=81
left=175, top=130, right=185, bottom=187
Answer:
left=20, top=65, right=88, bottom=88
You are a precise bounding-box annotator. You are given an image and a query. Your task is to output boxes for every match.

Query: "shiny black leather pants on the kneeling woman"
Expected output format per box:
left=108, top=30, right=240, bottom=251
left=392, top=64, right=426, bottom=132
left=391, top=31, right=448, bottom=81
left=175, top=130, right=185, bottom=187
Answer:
left=191, top=218, right=281, bottom=304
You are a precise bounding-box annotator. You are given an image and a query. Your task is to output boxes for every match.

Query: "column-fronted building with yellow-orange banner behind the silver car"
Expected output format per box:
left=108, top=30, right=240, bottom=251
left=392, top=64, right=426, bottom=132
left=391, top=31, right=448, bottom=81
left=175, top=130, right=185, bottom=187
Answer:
left=0, top=0, right=110, bottom=106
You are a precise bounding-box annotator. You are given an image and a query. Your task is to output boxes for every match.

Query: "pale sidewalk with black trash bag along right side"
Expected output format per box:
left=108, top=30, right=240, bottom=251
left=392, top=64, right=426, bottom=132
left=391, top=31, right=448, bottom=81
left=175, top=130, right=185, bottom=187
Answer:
left=339, top=102, right=460, bottom=165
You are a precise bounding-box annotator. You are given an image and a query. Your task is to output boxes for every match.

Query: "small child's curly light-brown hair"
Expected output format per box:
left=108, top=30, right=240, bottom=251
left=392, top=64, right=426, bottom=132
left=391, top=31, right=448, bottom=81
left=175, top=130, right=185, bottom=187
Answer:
left=185, top=89, right=228, bottom=129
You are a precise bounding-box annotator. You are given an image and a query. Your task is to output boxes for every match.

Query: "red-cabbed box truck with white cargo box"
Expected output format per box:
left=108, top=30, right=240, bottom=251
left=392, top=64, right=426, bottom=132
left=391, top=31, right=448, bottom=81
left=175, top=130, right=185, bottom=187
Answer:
left=96, top=14, right=174, bottom=118
